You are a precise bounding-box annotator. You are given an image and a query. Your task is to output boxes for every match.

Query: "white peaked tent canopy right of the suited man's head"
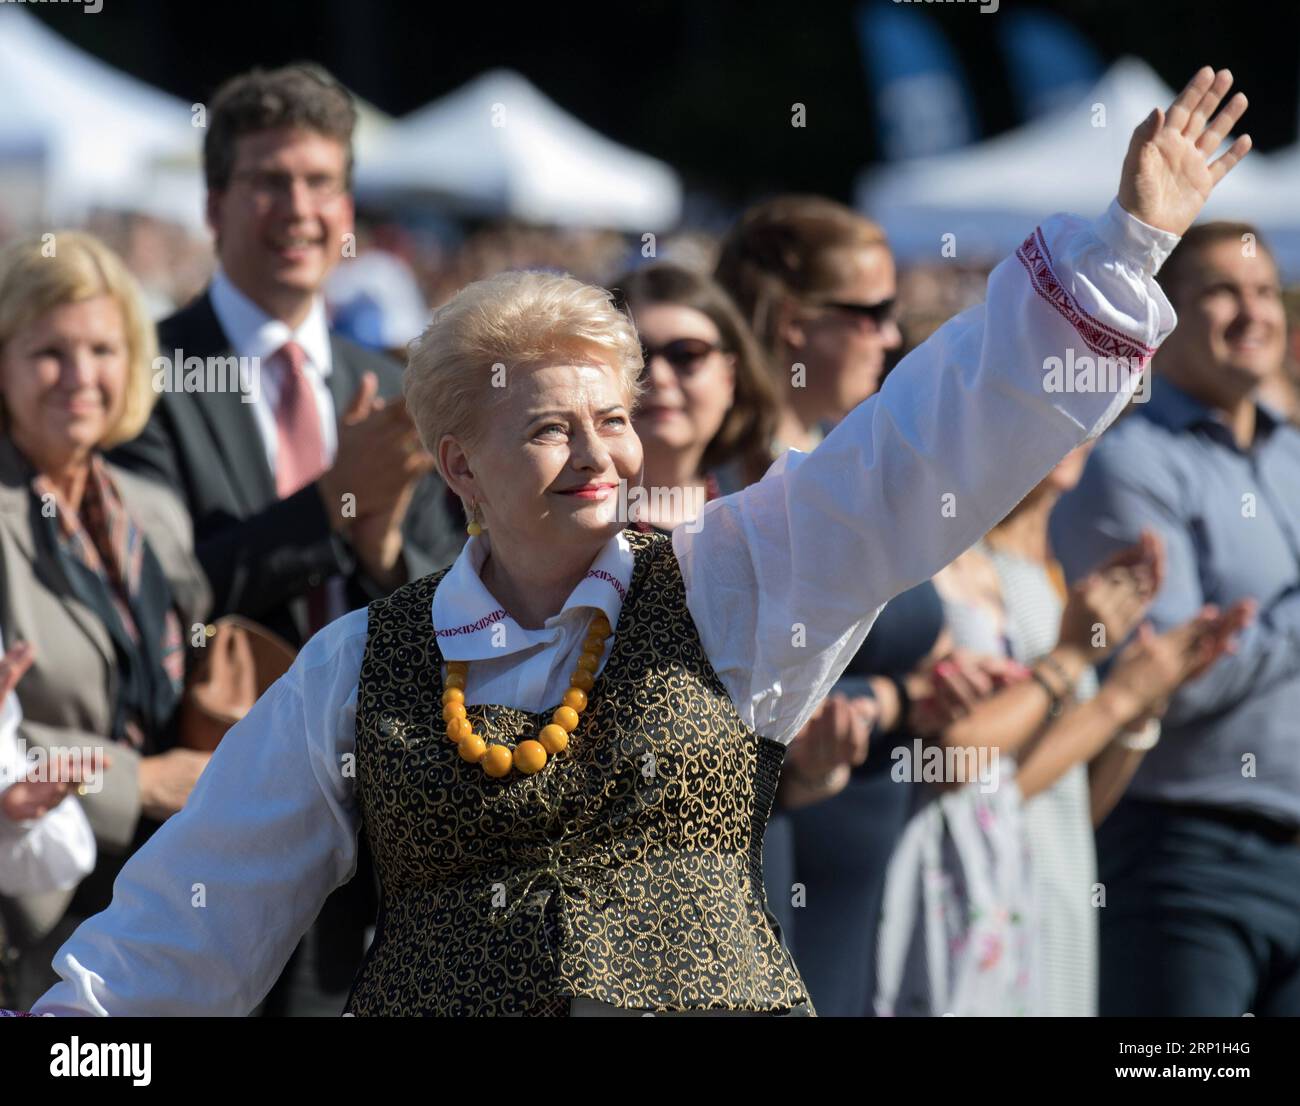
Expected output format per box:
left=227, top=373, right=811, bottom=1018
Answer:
left=358, top=70, right=681, bottom=231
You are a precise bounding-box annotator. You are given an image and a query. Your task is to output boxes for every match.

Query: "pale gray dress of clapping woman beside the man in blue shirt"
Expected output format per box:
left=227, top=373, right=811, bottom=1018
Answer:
left=983, top=545, right=1097, bottom=1018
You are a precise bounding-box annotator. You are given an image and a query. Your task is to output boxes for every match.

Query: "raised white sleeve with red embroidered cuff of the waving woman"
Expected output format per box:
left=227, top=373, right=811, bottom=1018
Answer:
left=672, top=201, right=1178, bottom=742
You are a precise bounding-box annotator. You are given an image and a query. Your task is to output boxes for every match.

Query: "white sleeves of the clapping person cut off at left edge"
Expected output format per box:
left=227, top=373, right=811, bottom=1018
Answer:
left=0, top=639, right=95, bottom=895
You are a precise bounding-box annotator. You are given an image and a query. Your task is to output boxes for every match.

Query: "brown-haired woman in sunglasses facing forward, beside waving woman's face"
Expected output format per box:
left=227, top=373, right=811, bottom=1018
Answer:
left=615, top=263, right=777, bottom=533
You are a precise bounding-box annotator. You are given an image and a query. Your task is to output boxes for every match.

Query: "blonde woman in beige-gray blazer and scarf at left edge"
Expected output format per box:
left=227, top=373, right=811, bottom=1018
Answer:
left=0, top=231, right=208, bottom=1005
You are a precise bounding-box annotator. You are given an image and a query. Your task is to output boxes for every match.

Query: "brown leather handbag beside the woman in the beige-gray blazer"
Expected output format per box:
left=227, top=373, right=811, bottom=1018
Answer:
left=179, top=615, right=295, bottom=752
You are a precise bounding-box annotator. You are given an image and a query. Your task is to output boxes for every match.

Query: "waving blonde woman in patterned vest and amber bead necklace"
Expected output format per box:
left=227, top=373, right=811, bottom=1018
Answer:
left=35, top=69, right=1249, bottom=1015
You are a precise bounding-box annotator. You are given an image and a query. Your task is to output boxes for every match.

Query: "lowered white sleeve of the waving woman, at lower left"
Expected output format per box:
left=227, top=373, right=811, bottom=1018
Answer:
left=33, top=610, right=367, bottom=1016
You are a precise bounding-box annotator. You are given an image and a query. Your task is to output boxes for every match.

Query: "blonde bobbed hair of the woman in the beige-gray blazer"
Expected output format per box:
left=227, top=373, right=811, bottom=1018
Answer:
left=0, top=230, right=157, bottom=450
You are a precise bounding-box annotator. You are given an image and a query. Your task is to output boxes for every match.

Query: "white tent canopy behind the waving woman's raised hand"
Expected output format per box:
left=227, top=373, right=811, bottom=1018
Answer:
left=857, top=57, right=1300, bottom=276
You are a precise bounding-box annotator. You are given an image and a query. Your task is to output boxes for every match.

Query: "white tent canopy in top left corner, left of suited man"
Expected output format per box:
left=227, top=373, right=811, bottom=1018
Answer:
left=0, top=4, right=202, bottom=227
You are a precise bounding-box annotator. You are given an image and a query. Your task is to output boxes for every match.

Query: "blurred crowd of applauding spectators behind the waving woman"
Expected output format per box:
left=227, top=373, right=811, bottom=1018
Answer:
left=0, top=69, right=1300, bottom=1016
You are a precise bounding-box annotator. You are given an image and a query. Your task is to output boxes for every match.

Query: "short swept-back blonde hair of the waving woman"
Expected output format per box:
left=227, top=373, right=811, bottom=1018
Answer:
left=402, top=272, right=642, bottom=475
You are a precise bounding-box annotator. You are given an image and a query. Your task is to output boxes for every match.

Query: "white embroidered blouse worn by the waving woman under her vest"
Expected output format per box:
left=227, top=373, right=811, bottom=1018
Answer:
left=34, top=203, right=1178, bottom=1015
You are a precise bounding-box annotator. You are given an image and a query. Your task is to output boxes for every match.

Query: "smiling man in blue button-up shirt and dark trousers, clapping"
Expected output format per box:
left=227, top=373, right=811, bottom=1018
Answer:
left=1050, top=222, right=1300, bottom=1016
